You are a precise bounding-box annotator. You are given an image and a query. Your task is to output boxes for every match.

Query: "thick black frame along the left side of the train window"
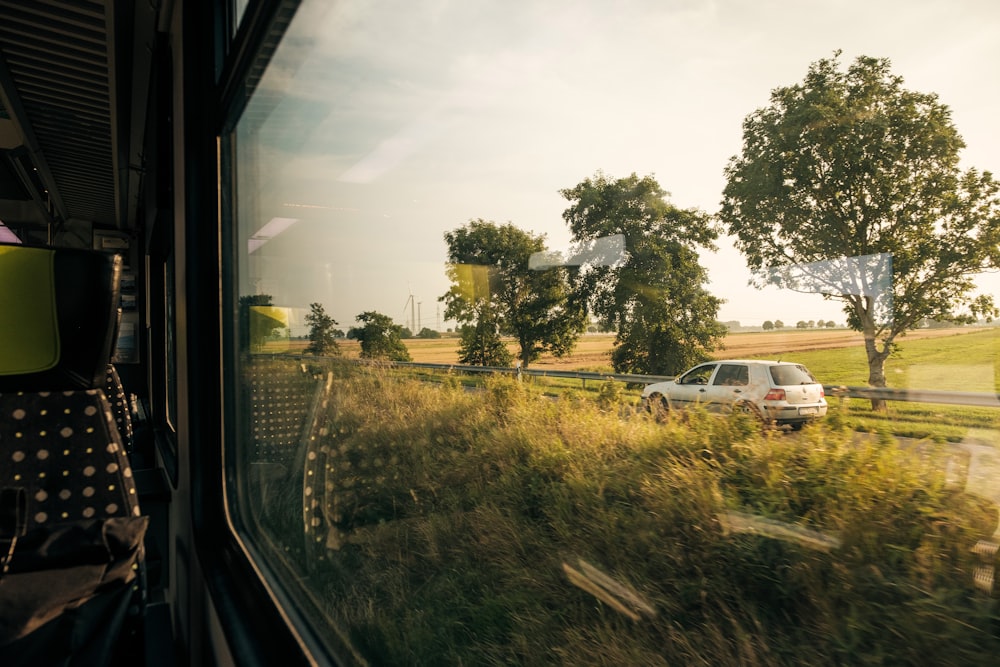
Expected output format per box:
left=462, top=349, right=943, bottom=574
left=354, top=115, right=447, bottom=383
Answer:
left=184, top=0, right=342, bottom=666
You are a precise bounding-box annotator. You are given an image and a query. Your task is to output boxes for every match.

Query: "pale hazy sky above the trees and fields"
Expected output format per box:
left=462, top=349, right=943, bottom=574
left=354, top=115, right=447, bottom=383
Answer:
left=241, top=0, right=1000, bottom=329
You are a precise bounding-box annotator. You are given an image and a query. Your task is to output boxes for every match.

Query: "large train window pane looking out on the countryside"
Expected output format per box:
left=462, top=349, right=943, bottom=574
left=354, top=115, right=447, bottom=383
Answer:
left=226, top=0, right=1000, bottom=665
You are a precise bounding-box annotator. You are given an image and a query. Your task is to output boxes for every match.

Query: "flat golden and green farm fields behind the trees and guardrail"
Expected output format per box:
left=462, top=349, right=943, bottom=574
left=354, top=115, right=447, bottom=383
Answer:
left=284, top=327, right=1000, bottom=442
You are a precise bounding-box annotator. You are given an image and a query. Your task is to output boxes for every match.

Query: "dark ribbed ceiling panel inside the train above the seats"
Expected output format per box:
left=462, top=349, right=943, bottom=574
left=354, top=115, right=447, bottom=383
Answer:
left=0, top=0, right=159, bottom=240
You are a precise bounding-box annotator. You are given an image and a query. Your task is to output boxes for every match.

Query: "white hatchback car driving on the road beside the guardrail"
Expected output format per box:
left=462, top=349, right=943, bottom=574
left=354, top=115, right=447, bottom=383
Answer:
left=642, top=359, right=827, bottom=429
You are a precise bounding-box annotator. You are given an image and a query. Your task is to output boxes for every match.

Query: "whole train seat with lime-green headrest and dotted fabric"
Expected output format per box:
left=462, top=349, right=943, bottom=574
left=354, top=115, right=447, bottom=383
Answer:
left=0, top=245, right=148, bottom=667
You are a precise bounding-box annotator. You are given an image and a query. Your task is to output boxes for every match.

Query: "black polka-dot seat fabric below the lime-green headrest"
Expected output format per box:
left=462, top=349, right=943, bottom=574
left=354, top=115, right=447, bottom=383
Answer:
left=0, top=390, right=148, bottom=664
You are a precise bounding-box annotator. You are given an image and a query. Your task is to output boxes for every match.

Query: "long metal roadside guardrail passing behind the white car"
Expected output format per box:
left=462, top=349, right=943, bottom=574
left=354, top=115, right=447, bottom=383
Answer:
left=286, top=355, right=1000, bottom=408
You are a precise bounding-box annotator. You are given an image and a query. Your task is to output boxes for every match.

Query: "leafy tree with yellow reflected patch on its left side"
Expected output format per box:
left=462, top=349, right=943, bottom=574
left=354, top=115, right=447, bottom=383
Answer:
left=440, top=219, right=586, bottom=368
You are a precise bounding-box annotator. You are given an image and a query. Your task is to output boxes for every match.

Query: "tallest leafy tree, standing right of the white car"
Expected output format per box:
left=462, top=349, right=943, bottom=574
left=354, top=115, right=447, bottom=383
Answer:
left=720, top=52, right=1000, bottom=409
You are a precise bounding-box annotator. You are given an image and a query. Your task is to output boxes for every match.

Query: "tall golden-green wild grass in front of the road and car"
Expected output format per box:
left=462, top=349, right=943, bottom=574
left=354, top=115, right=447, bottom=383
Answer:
left=262, top=369, right=1000, bottom=665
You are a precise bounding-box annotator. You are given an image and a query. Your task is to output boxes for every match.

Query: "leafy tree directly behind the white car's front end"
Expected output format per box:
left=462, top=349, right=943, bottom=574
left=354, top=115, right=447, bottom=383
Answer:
left=561, top=172, right=726, bottom=375
